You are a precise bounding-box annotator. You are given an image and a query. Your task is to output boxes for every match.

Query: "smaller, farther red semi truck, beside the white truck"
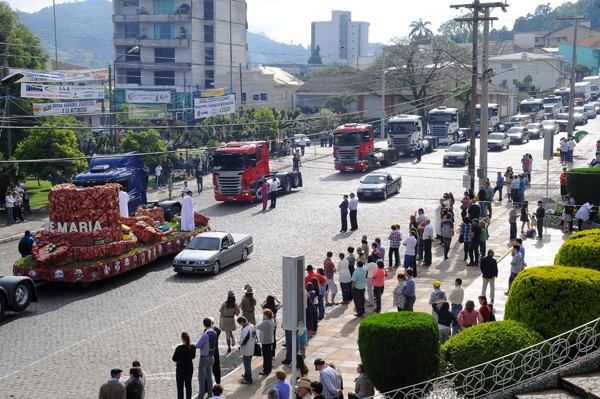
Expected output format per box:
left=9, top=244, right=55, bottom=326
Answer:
left=333, top=123, right=398, bottom=172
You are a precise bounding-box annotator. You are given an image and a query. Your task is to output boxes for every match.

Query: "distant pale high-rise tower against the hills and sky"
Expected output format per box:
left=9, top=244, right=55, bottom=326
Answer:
left=310, top=10, right=369, bottom=65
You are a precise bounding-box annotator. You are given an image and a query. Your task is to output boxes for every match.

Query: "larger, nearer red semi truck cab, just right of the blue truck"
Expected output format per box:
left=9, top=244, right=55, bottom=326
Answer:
left=213, top=141, right=302, bottom=202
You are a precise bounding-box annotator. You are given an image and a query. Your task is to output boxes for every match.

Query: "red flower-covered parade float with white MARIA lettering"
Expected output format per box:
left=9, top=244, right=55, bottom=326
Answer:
left=13, top=183, right=210, bottom=283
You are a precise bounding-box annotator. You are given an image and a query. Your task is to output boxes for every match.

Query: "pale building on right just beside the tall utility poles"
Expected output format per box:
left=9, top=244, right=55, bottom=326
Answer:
left=489, top=51, right=571, bottom=91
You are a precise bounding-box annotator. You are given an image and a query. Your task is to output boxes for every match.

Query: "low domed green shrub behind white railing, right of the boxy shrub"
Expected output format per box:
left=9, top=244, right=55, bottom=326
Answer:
left=441, top=320, right=544, bottom=370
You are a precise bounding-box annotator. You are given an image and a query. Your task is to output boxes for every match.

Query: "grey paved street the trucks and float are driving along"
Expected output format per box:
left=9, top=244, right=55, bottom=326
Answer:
left=0, top=120, right=600, bottom=399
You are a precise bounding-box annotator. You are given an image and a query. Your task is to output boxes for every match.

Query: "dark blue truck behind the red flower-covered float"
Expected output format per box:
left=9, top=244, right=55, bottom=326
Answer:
left=73, top=151, right=181, bottom=221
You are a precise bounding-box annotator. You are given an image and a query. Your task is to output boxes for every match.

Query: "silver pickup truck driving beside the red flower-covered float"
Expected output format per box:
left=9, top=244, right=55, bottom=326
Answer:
left=173, top=231, right=254, bottom=274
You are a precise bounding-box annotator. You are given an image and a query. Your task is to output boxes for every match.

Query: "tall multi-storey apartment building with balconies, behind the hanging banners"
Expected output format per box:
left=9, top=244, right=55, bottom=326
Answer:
left=113, top=0, right=248, bottom=101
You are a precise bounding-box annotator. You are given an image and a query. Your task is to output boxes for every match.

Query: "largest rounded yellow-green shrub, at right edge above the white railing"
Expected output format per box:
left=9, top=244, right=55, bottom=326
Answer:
left=504, top=266, right=600, bottom=338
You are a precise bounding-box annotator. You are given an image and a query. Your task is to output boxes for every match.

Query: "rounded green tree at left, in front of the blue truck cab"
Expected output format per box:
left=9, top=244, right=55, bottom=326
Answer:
left=15, top=117, right=87, bottom=184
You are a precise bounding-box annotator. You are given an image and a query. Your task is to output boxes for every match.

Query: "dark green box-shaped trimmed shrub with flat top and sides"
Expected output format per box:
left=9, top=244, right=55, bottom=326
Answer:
left=358, top=312, right=440, bottom=392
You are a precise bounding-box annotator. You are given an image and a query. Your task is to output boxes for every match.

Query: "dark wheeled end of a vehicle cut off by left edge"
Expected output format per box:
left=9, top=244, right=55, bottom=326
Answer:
left=0, top=276, right=37, bottom=321
